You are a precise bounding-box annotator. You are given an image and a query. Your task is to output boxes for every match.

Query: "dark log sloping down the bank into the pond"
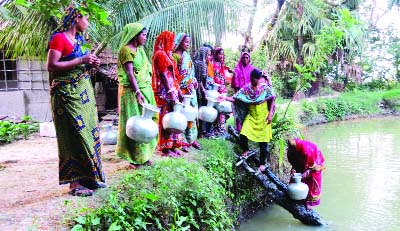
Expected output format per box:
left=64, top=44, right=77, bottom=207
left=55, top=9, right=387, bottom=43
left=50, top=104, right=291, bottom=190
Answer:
left=228, top=126, right=326, bottom=226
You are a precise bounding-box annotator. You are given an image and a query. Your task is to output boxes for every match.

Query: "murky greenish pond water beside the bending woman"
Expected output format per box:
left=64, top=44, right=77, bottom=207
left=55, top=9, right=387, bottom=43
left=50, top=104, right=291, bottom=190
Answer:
left=240, top=117, right=400, bottom=231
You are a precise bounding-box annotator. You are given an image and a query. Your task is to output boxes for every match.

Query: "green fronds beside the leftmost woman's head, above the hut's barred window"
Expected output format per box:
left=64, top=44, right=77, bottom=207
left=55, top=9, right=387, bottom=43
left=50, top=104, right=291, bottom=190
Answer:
left=0, top=0, right=110, bottom=58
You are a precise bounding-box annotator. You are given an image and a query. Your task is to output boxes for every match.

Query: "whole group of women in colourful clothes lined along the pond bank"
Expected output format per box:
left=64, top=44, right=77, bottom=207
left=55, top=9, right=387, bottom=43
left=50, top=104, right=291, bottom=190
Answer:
left=47, top=6, right=324, bottom=209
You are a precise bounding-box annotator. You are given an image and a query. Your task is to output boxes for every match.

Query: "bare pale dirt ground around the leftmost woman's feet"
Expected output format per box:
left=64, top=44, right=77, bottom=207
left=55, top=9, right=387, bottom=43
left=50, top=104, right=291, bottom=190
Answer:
left=0, top=135, right=127, bottom=231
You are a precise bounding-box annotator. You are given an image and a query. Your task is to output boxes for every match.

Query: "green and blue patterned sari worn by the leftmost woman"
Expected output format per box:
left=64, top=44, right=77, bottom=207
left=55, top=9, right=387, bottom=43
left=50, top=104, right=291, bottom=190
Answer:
left=50, top=35, right=105, bottom=184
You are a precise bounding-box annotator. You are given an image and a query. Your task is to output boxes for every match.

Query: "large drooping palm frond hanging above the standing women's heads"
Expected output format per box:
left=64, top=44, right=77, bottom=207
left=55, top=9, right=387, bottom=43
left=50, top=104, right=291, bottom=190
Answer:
left=92, top=0, right=251, bottom=50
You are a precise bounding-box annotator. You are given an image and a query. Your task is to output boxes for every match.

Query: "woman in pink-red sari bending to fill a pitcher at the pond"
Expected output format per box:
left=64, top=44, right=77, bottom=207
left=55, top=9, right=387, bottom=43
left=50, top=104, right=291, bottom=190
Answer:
left=287, top=139, right=325, bottom=208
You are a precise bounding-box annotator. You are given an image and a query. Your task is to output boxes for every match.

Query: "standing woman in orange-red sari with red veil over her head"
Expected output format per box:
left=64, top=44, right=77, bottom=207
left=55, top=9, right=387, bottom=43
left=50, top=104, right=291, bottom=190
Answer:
left=152, top=31, right=183, bottom=157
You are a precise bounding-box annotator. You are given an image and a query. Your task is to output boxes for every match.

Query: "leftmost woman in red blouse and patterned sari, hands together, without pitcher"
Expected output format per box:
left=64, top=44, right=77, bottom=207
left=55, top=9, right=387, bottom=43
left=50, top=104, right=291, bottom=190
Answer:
left=47, top=6, right=105, bottom=196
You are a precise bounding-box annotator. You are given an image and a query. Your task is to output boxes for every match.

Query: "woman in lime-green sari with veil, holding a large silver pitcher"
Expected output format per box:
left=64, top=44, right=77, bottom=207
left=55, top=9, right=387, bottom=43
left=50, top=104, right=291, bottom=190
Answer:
left=116, top=23, right=158, bottom=169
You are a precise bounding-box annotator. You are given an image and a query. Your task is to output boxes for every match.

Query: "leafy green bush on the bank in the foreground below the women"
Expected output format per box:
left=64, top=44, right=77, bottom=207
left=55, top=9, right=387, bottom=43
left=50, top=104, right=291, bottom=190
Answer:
left=74, top=159, right=232, bottom=230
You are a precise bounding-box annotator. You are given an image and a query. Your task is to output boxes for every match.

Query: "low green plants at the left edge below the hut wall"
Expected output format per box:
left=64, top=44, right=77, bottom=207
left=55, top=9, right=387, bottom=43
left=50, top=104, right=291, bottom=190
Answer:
left=0, top=116, right=39, bottom=144
